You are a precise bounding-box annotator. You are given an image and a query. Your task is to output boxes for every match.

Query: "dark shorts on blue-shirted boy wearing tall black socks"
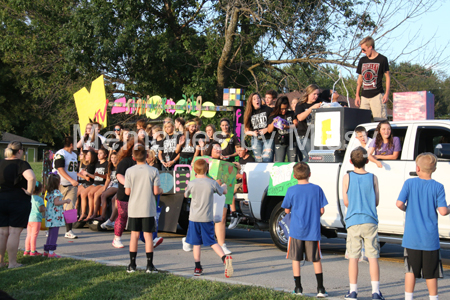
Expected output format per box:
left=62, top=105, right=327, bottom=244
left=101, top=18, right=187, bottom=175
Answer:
left=286, top=237, right=322, bottom=262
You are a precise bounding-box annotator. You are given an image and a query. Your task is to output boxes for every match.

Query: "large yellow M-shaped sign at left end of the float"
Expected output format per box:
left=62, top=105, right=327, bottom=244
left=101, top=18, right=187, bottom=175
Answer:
left=73, top=75, right=108, bottom=134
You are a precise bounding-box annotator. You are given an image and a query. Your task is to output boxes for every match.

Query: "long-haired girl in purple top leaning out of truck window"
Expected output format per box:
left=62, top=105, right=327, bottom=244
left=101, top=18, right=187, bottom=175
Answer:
left=368, top=121, right=402, bottom=168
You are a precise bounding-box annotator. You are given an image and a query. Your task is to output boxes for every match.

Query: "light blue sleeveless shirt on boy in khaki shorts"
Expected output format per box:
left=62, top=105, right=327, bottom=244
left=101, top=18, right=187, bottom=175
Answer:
left=345, top=172, right=378, bottom=228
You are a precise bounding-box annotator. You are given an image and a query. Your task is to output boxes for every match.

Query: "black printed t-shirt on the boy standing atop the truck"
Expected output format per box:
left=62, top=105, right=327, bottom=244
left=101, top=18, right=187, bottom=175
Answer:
left=356, top=53, right=389, bottom=98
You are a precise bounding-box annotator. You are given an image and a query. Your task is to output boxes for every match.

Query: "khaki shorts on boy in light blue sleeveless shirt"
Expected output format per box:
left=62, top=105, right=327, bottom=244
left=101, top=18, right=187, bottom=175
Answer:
left=347, top=223, right=380, bottom=258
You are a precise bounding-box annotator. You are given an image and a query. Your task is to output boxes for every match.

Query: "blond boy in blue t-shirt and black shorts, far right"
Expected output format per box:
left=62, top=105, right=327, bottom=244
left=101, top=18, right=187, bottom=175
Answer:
left=397, top=152, right=450, bottom=300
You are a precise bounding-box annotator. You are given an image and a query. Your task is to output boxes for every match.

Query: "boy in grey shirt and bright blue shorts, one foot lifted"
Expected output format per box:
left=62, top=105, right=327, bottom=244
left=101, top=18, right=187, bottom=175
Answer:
left=184, top=159, right=233, bottom=278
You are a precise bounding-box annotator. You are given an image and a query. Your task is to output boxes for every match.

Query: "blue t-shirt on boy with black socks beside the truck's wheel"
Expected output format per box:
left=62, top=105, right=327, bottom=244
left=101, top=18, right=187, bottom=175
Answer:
left=281, top=183, right=328, bottom=241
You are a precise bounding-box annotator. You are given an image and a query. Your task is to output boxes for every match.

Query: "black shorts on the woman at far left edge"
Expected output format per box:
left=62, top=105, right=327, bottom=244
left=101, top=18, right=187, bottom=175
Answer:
left=0, top=200, right=31, bottom=228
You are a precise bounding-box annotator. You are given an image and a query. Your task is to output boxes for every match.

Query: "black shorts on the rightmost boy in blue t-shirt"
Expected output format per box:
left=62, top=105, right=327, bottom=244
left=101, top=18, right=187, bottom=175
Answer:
left=404, top=248, right=444, bottom=279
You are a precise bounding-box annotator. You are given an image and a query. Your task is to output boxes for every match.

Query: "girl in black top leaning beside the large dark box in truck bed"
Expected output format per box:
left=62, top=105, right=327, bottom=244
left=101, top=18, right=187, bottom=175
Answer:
left=295, top=84, right=321, bottom=161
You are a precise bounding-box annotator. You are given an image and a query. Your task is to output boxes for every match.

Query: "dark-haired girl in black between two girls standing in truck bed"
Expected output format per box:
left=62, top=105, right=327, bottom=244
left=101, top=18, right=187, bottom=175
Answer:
left=267, top=96, right=298, bottom=162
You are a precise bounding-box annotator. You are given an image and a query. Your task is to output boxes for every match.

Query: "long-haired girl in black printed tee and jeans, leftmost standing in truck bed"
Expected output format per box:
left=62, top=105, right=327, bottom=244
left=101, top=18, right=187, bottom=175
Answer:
left=244, top=93, right=273, bottom=162
